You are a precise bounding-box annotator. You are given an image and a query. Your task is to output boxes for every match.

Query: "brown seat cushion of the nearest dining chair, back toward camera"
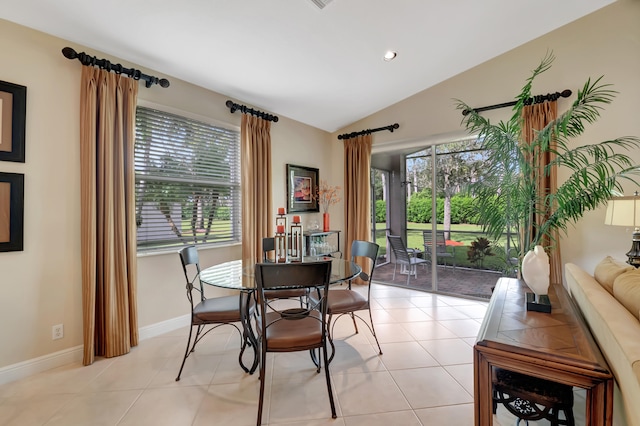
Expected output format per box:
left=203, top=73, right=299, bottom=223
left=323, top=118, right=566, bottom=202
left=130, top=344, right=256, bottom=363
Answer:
left=258, top=311, right=322, bottom=352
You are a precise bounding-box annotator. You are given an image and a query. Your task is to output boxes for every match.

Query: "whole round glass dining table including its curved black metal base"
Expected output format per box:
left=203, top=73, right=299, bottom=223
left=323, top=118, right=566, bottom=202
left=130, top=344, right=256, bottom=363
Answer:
left=200, top=256, right=362, bottom=374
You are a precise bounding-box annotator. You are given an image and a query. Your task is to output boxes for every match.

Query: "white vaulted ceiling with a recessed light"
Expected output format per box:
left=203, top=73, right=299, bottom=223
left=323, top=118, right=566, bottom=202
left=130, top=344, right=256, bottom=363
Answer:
left=0, top=0, right=614, bottom=132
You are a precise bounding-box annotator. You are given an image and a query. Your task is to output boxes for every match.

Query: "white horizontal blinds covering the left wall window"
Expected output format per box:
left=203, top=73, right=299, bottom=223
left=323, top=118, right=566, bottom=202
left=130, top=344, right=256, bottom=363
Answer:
left=135, top=106, right=241, bottom=250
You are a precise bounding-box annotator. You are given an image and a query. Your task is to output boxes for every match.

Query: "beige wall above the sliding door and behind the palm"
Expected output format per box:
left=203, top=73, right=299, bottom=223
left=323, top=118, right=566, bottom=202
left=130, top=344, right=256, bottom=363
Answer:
left=334, top=0, right=640, bottom=271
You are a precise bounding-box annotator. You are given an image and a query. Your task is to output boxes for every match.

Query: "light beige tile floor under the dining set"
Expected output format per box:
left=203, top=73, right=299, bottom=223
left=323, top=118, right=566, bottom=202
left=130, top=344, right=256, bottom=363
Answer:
left=0, top=285, right=579, bottom=426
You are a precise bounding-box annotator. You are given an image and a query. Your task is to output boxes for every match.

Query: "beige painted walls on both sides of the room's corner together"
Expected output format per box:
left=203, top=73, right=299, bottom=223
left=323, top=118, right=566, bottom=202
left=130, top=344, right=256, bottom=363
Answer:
left=0, top=0, right=640, bottom=380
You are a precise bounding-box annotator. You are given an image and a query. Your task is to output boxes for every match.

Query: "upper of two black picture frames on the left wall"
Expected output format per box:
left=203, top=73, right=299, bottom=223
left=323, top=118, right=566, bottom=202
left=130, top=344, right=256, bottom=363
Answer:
left=0, top=81, right=27, bottom=163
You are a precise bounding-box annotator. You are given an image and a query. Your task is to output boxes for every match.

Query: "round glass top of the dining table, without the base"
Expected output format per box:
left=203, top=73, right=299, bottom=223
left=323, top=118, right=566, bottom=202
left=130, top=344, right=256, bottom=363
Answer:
left=200, top=256, right=362, bottom=290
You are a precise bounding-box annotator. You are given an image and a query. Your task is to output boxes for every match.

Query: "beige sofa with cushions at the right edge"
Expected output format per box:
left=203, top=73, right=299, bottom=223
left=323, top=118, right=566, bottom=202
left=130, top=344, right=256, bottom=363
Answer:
left=565, top=257, right=640, bottom=426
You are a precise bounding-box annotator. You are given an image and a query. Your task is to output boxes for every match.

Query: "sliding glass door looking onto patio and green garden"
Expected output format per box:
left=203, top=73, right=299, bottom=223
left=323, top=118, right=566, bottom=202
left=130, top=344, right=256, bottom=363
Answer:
left=406, top=138, right=510, bottom=298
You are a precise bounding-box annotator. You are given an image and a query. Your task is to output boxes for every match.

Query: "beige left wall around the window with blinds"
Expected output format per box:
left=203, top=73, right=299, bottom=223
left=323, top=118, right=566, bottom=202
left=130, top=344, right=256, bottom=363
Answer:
left=0, top=20, right=341, bottom=372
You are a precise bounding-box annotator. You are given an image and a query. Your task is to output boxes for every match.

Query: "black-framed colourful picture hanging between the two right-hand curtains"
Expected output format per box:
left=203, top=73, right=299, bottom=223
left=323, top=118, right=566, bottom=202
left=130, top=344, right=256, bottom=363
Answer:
left=287, top=164, right=320, bottom=213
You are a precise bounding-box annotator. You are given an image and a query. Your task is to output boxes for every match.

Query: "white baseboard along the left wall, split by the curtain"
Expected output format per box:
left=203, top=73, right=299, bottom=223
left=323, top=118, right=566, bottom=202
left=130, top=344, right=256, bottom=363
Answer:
left=0, top=314, right=191, bottom=385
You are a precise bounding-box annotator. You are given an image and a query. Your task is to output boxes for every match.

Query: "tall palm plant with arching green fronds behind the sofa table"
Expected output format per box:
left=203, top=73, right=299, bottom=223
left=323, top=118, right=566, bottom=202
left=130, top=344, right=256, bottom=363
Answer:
left=457, top=53, right=640, bottom=276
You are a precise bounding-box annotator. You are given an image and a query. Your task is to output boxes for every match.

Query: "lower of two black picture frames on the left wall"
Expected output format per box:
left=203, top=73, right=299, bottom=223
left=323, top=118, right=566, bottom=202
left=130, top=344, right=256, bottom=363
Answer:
left=0, top=172, right=24, bottom=252
